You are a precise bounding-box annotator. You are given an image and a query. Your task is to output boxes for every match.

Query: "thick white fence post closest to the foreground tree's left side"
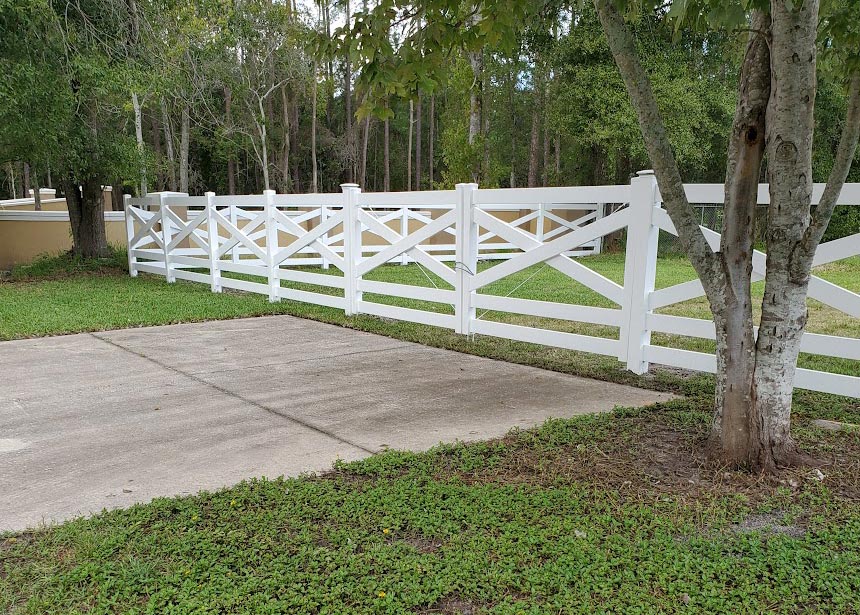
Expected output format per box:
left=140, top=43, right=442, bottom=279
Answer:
left=619, top=171, right=659, bottom=374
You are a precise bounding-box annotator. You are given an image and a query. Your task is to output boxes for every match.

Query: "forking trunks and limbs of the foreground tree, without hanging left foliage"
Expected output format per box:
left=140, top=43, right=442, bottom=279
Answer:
left=595, top=0, right=860, bottom=471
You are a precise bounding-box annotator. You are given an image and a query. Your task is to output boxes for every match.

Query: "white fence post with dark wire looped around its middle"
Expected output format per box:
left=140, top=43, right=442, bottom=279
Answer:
left=454, top=184, right=478, bottom=335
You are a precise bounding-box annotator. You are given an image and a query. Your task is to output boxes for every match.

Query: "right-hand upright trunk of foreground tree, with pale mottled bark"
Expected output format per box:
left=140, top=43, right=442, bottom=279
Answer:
left=750, top=0, right=818, bottom=471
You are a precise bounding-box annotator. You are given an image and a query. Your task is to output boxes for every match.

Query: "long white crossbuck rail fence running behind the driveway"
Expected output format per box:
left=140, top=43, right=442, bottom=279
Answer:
left=125, top=172, right=860, bottom=397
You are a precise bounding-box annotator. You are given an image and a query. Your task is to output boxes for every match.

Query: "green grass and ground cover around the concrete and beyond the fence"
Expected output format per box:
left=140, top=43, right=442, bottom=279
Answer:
left=5, top=253, right=860, bottom=615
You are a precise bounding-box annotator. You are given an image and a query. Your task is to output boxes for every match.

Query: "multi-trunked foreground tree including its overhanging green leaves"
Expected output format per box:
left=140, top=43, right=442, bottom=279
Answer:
left=340, top=0, right=860, bottom=471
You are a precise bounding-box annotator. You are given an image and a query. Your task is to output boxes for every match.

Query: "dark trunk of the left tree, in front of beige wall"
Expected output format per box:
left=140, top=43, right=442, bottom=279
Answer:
left=63, top=178, right=108, bottom=259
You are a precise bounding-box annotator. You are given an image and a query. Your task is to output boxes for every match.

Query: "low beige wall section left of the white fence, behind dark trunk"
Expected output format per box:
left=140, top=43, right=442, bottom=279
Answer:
left=0, top=220, right=126, bottom=269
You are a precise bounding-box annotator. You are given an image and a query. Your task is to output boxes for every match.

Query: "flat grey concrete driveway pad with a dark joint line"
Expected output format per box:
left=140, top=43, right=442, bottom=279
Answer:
left=0, top=316, right=670, bottom=531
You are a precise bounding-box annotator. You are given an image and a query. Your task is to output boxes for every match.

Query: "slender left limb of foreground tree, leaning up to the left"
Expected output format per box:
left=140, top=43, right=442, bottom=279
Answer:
left=594, top=0, right=717, bottom=288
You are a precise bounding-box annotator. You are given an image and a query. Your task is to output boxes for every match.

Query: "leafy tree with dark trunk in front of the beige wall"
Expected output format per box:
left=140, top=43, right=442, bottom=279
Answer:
left=0, top=0, right=139, bottom=258
